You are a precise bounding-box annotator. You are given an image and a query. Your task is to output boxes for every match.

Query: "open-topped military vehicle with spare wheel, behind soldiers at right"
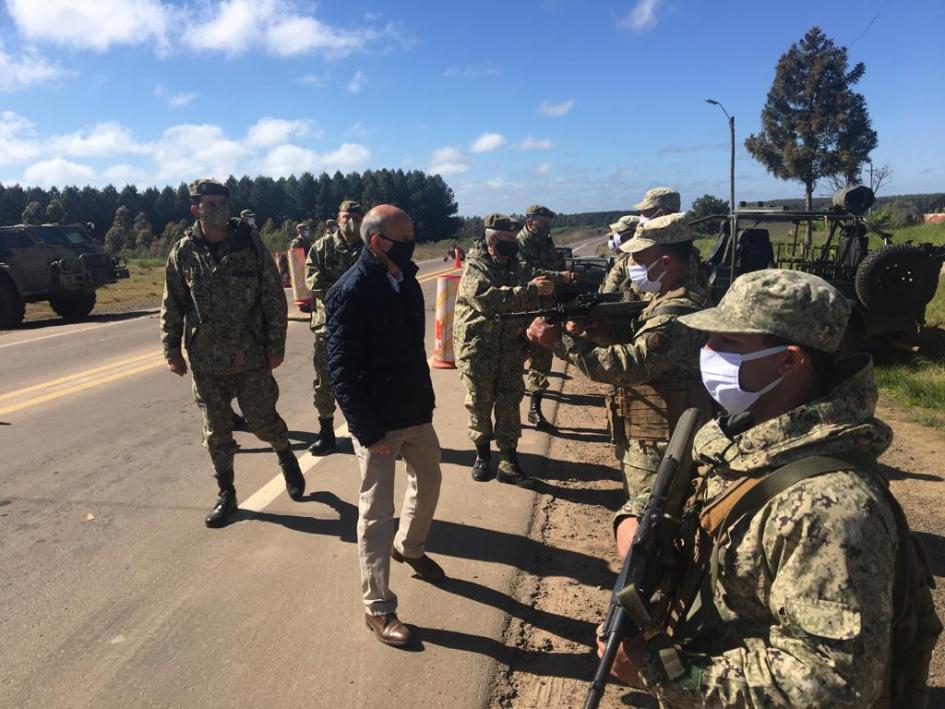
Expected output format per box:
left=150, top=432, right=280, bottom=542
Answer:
left=693, top=185, right=945, bottom=346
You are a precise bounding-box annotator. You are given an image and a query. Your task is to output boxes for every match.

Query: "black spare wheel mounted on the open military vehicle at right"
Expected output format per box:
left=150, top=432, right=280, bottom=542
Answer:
left=855, top=244, right=938, bottom=311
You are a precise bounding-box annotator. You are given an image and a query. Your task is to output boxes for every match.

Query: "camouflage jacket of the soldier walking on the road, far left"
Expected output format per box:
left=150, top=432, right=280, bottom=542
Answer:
left=161, top=219, right=288, bottom=374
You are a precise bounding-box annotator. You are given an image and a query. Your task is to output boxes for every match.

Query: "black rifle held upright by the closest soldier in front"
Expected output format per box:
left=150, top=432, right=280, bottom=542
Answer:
left=584, top=408, right=706, bottom=709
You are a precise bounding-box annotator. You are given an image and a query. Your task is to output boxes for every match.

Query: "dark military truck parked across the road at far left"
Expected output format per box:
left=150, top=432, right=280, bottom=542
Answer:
left=0, top=224, right=129, bottom=329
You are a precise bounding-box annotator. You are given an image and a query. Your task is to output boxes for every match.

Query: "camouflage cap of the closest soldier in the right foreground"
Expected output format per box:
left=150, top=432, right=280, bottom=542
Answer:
left=679, top=268, right=850, bottom=353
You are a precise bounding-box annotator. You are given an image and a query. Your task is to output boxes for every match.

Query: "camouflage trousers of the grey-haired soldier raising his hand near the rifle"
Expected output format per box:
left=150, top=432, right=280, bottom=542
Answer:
left=459, top=363, right=525, bottom=451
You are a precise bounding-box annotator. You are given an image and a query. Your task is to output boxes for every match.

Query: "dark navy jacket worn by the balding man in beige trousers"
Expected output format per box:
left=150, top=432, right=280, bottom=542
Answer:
left=325, top=248, right=435, bottom=446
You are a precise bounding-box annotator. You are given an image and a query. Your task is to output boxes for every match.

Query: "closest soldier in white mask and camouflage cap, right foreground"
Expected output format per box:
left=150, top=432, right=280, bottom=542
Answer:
left=600, top=270, right=932, bottom=709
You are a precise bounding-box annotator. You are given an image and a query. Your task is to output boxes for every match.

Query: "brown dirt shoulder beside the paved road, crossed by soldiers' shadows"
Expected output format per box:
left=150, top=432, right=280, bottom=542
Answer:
left=490, top=368, right=945, bottom=709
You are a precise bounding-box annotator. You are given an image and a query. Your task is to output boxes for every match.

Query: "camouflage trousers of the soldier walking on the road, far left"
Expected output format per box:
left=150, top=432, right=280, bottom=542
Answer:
left=194, top=369, right=289, bottom=480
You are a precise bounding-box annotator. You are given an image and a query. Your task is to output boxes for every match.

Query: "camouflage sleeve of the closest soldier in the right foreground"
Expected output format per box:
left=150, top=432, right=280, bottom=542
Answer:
left=654, top=472, right=896, bottom=708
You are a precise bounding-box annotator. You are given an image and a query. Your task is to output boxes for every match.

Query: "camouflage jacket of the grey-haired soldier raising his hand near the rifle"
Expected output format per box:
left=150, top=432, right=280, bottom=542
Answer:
left=453, top=248, right=539, bottom=369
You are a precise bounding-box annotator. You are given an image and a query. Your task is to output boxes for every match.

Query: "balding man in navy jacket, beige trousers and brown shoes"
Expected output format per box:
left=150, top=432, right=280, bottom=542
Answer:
left=325, top=204, right=445, bottom=646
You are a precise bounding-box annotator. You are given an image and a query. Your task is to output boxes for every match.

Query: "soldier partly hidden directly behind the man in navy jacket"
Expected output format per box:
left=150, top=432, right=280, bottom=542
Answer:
left=305, top=199, right=364, bottom=455
